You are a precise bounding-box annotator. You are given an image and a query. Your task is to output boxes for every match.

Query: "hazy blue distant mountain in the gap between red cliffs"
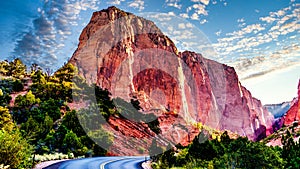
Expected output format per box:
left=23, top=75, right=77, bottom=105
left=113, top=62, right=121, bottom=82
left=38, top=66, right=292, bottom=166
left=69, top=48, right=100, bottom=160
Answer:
left=264, top=102, right=291, bottom=118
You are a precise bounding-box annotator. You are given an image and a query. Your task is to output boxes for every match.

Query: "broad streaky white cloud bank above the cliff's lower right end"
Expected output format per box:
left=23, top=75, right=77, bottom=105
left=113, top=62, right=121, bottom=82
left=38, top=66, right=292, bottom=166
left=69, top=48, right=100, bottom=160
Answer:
left=213, top=4, right=300, bottom=80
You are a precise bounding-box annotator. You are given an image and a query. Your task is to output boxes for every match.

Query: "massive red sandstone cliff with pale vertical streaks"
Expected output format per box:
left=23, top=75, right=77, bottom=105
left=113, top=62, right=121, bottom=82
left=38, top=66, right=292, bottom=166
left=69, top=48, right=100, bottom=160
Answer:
left=69, top=7, right=273, bottom=154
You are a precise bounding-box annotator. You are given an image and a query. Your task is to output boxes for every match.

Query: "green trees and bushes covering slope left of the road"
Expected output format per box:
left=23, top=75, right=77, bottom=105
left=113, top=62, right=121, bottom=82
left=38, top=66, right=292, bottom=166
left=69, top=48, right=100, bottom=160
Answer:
left=0, top=59, right=159, bottom=168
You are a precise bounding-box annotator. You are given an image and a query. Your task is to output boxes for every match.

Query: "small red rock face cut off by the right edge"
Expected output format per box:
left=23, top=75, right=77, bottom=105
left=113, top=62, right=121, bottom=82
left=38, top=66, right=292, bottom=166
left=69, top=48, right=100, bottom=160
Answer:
left=284, top=79, right=300, bottom=126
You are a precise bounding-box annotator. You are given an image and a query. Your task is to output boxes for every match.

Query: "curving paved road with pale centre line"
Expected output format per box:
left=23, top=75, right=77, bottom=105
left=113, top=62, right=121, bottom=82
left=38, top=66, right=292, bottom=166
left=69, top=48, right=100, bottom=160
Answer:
left=45, top=157, right=145, bottom=169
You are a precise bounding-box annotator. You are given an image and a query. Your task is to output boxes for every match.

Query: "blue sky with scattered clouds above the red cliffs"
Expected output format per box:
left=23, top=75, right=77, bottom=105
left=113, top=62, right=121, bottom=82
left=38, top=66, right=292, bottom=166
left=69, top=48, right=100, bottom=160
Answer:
left=0, top=0, right=300, bottom=104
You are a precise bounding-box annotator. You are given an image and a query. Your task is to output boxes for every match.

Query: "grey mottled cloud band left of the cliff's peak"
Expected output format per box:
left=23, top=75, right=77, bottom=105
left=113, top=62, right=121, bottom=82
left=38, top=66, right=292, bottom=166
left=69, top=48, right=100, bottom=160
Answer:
left=13, top=0, right=98, bottom=68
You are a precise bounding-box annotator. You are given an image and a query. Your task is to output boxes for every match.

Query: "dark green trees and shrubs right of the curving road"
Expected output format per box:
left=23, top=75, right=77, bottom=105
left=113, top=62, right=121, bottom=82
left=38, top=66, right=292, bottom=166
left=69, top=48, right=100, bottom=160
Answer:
left=151, top=125, right=300, bottom=169
